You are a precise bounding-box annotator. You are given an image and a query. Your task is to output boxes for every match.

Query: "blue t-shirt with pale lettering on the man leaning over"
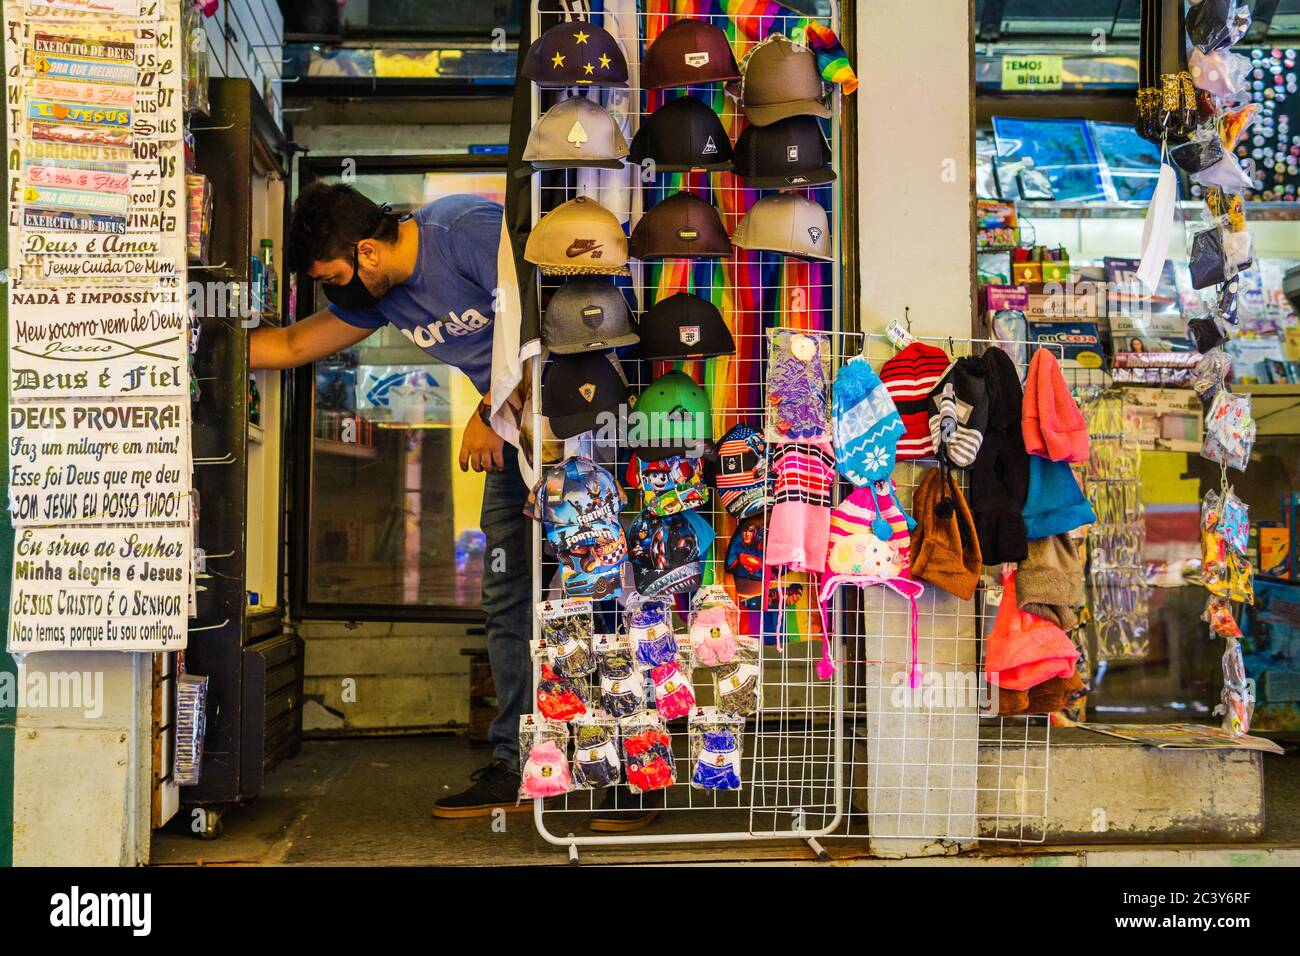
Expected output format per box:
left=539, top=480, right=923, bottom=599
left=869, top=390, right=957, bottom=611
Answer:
left=329, top=195, right=502, bottom=394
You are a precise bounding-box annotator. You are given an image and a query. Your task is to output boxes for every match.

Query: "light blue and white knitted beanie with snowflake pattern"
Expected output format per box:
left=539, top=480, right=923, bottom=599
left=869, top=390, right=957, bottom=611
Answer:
left=831, top=355, right=906, bottom=488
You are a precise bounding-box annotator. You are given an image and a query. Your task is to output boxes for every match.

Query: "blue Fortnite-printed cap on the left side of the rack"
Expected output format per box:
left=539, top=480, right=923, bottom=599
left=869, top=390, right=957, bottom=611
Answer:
left=537, top=457, right=628, bottom=598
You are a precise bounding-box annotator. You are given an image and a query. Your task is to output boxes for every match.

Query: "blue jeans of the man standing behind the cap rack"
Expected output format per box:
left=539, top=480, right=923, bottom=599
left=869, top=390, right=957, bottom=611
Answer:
left=480, top=444, right=533, bottom=770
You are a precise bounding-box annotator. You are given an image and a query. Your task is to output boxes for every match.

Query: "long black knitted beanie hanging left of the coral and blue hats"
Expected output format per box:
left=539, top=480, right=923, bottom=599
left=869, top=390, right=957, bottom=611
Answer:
left=970, top=347, right=1030, bottom=564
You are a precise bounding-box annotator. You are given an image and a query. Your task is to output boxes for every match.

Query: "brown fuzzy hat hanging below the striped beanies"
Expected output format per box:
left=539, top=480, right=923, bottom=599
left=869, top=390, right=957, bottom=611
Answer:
left=911, top=468, right=982, bottom=601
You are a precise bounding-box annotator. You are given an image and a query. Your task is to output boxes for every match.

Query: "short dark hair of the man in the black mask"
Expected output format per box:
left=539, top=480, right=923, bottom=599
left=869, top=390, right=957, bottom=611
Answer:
left=285, top=182, right=398, bottom=272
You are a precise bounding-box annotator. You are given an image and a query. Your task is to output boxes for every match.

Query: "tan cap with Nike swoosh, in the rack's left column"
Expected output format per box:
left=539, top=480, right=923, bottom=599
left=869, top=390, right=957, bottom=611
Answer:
left=524, top=196, right=631, bottom=276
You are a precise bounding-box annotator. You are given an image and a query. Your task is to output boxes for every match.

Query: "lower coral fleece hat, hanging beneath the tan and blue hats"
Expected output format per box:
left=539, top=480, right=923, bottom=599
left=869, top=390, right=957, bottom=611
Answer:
left=984, top=571, right=1079, bottom=691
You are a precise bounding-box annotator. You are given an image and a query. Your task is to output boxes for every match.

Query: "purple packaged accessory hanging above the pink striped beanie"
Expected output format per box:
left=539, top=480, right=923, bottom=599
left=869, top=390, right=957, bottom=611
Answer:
left=767, top=329, right=831, bottom=442
